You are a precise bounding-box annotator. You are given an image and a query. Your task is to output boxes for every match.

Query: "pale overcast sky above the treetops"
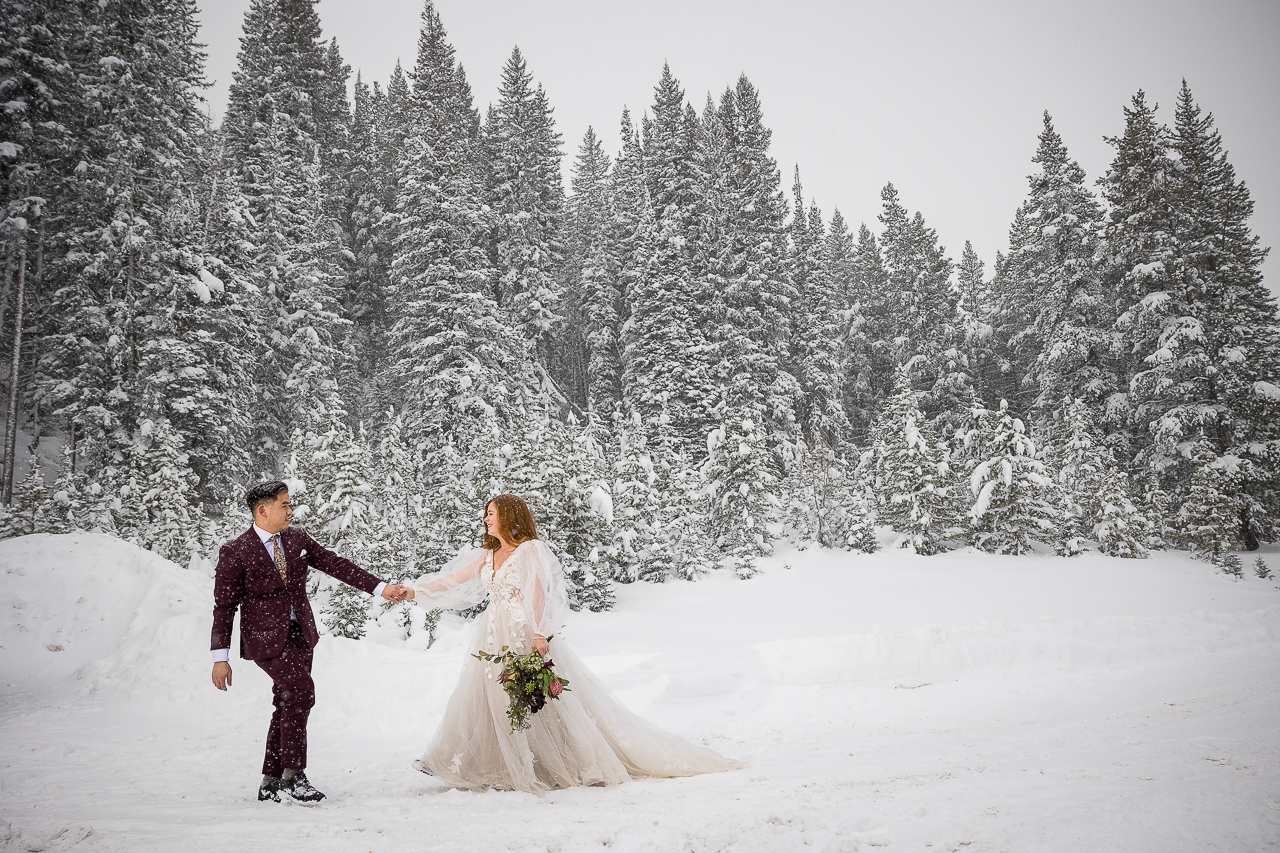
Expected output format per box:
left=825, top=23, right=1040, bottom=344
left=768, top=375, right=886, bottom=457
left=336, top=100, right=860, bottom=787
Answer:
left=198, top=0, right=1280, bottom=291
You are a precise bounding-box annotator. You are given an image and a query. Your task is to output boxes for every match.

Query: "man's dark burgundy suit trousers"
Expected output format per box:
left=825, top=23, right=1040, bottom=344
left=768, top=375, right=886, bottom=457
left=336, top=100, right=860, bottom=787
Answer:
left=253, top=621, right=316, bottom=776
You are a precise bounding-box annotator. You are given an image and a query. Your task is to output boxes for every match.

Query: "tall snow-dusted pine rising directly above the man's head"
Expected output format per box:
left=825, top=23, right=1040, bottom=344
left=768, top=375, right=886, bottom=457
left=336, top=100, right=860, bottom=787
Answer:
left=223, top=0, right=347, bottom=470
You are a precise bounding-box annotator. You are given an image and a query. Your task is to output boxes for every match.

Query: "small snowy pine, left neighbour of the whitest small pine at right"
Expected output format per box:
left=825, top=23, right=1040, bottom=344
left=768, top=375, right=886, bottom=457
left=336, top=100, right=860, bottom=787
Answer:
left=861, top=366, right=960, bottom=555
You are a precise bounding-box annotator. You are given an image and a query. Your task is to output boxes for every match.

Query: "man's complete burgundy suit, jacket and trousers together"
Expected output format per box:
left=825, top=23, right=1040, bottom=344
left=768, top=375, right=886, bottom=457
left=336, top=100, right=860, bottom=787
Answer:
left=210, top=528, right=381, bottom=776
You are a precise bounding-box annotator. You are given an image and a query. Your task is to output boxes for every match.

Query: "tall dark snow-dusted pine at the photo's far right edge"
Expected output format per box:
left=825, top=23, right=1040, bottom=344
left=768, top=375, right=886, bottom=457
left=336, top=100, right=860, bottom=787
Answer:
left=1167, top=81, right=1280, bottom=540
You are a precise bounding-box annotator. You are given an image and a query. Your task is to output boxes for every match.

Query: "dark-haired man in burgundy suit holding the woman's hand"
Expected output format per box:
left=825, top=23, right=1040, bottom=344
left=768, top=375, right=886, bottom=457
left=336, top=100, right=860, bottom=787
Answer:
left=211, top=480, right=410, bottom=803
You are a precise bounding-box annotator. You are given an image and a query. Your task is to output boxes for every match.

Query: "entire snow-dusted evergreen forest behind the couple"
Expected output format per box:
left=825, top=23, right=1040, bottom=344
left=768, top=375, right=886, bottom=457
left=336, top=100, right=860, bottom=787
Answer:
left=0, top=0, right=1280, bottom=637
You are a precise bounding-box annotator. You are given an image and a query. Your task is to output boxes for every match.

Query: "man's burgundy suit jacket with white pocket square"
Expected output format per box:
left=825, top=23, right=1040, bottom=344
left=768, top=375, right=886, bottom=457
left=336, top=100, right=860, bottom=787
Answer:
left=210, top=528, right=381, bottom=661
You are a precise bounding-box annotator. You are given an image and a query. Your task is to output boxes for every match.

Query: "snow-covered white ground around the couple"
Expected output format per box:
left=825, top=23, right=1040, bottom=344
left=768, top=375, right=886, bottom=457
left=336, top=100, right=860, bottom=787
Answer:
left=0, top=534, right=1280, bottom=853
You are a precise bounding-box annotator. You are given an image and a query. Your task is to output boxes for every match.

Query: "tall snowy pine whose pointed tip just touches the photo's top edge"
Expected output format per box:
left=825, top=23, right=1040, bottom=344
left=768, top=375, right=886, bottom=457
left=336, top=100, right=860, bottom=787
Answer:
left=388, top=1, right=536, bottom=451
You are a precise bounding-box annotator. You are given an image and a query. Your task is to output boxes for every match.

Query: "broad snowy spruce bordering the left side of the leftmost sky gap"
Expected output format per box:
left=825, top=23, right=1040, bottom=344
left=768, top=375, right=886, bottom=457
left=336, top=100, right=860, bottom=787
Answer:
left=41, top=0, right=225, bottom=532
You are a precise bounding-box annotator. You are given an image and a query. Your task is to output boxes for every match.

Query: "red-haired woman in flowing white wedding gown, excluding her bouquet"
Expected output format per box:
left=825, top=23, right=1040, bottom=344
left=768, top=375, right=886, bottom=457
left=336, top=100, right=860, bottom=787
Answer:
left=410, top=494, right=745, bottom=793
